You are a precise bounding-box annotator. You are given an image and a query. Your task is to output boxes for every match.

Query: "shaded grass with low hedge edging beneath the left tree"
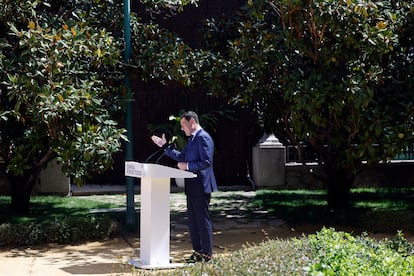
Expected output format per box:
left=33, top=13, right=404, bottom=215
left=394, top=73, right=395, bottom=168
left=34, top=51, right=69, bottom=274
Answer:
left=0, top=196, right=120, bottom=247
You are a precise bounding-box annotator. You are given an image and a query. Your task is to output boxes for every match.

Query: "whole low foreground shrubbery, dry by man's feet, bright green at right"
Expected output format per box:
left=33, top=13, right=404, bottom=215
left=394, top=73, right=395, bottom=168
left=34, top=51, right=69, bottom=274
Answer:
left=181, top=228, right=414, bottom=275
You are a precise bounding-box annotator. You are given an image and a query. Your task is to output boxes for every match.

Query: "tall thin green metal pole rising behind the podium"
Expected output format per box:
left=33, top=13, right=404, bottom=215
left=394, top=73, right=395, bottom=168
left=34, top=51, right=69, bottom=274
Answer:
left=124, top=0, right=138, bottom=232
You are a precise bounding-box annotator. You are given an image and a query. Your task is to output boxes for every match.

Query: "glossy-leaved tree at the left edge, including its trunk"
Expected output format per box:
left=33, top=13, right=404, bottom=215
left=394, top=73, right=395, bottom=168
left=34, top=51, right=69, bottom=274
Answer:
left=0, top=1, right=125, bottom=211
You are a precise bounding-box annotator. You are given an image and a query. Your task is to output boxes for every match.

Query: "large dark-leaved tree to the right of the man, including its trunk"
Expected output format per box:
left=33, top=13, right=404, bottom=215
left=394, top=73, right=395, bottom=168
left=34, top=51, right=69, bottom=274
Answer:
left=202, top=0, right=414, bottom=208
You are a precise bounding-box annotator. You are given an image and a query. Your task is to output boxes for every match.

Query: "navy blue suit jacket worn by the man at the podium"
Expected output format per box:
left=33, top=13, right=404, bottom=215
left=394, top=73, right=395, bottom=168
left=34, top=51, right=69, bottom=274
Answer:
left=165, top=129, right=217, bottom=195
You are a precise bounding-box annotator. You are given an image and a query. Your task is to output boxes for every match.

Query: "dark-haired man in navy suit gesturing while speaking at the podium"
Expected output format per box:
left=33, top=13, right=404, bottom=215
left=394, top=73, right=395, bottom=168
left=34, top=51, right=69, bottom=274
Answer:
left=151, top=111, right=217, bottom=262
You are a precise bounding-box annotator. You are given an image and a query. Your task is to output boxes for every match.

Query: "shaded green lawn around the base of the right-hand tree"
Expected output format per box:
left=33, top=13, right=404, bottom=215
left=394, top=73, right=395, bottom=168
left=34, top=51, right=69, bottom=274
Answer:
left=252, top=189, right=414, bottom=233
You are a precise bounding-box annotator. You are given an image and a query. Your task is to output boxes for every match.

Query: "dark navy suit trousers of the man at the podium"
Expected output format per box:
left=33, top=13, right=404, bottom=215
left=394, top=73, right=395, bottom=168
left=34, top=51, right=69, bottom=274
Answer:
left=187, top=194, right=213, bottom=256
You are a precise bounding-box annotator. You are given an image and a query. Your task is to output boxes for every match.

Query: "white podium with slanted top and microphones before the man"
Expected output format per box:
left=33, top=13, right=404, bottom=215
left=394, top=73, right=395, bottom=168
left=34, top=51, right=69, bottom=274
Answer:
left=125, top=161, right=196, bottom=269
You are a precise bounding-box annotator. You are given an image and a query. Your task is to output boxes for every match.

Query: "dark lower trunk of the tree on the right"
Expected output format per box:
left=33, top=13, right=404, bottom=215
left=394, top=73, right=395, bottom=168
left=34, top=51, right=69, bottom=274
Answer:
left=327, top=169, right=354, bottom=209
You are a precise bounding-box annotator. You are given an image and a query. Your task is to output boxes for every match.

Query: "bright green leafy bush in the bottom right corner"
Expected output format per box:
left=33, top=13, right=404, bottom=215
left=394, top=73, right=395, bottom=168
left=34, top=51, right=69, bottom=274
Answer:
left=306, top=228, right=414, bottom=275
